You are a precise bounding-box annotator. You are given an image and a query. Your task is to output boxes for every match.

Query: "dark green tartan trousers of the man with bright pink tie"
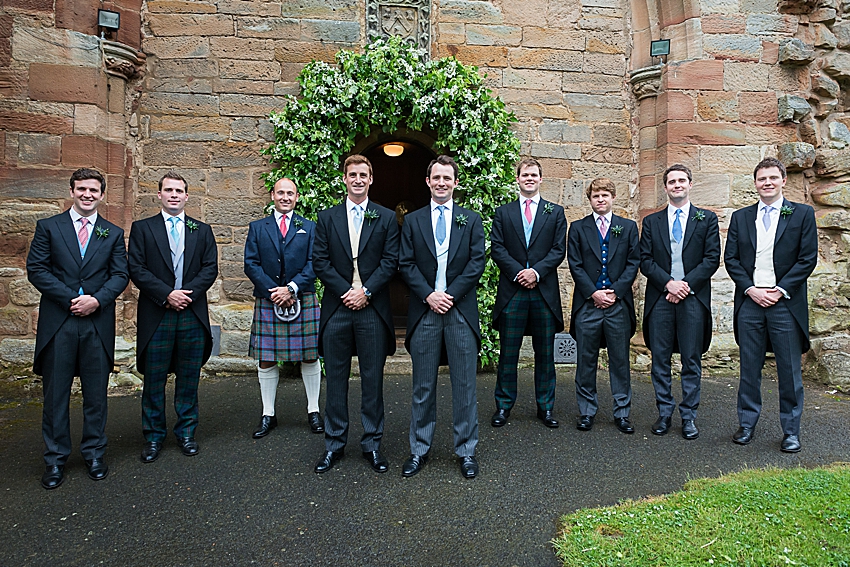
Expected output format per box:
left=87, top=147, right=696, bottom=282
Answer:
left=496, top=288, right=555, bottom=411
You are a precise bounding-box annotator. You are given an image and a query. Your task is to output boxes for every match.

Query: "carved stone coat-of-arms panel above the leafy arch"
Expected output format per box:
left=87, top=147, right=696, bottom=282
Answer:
left=366, top=0, right=431, bottom=59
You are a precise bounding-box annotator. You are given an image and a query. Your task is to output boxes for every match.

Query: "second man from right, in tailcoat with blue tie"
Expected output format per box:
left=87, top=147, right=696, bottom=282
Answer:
left=640, top=164, right=720, bottom=439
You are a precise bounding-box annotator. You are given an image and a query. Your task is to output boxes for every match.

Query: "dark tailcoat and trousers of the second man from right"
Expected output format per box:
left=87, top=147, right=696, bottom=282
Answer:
left=640, top=204, right=720, bottom=420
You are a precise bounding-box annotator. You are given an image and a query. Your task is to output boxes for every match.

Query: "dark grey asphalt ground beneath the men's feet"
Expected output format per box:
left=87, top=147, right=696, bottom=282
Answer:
left=0, top=368, right=850, bottom=567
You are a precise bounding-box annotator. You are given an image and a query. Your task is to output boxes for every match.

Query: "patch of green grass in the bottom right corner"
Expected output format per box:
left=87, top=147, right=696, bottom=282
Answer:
left=553, top=463, right=850, bottom=567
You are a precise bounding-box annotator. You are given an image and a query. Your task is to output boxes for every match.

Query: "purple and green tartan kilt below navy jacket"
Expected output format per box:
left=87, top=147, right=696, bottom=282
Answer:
left=248, top=292, right=319, bottom=362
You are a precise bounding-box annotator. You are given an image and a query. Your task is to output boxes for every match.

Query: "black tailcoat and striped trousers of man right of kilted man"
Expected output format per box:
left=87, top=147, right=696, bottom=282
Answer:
left=313, top=200, right=398, bottom=452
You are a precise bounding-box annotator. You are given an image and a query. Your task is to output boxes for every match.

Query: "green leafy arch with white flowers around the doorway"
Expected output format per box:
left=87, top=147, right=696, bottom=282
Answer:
left=264, top=38, right=520, bottom=366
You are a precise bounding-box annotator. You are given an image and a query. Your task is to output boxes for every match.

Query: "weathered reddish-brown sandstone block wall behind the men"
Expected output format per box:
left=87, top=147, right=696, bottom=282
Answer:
left=0, top=0, right=850, bottom=386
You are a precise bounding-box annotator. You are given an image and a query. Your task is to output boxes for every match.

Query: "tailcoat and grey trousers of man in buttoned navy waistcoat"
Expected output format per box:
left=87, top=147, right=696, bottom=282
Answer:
left=567, top=215, right=640, bottom=418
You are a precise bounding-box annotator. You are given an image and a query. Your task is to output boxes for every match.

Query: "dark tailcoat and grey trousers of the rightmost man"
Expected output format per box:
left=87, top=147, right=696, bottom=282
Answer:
left=724, top=199, right=818, bottom=435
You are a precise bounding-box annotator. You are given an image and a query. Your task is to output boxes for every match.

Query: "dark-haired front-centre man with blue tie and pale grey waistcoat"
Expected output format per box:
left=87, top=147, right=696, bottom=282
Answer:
left=399, top=155, right=485, bottom=478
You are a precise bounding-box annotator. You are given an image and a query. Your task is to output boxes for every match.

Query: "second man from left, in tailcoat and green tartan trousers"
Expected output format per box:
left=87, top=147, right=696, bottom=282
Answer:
left=128, top=171, right=218, bottom=463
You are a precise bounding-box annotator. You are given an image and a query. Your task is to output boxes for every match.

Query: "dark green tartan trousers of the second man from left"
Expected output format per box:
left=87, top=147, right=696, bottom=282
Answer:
left=142, top=309, right=206, bottom=443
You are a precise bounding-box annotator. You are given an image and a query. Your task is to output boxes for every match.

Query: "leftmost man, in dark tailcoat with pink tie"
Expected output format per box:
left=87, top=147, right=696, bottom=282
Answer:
left=27, top=168, right=129, bottom=490
